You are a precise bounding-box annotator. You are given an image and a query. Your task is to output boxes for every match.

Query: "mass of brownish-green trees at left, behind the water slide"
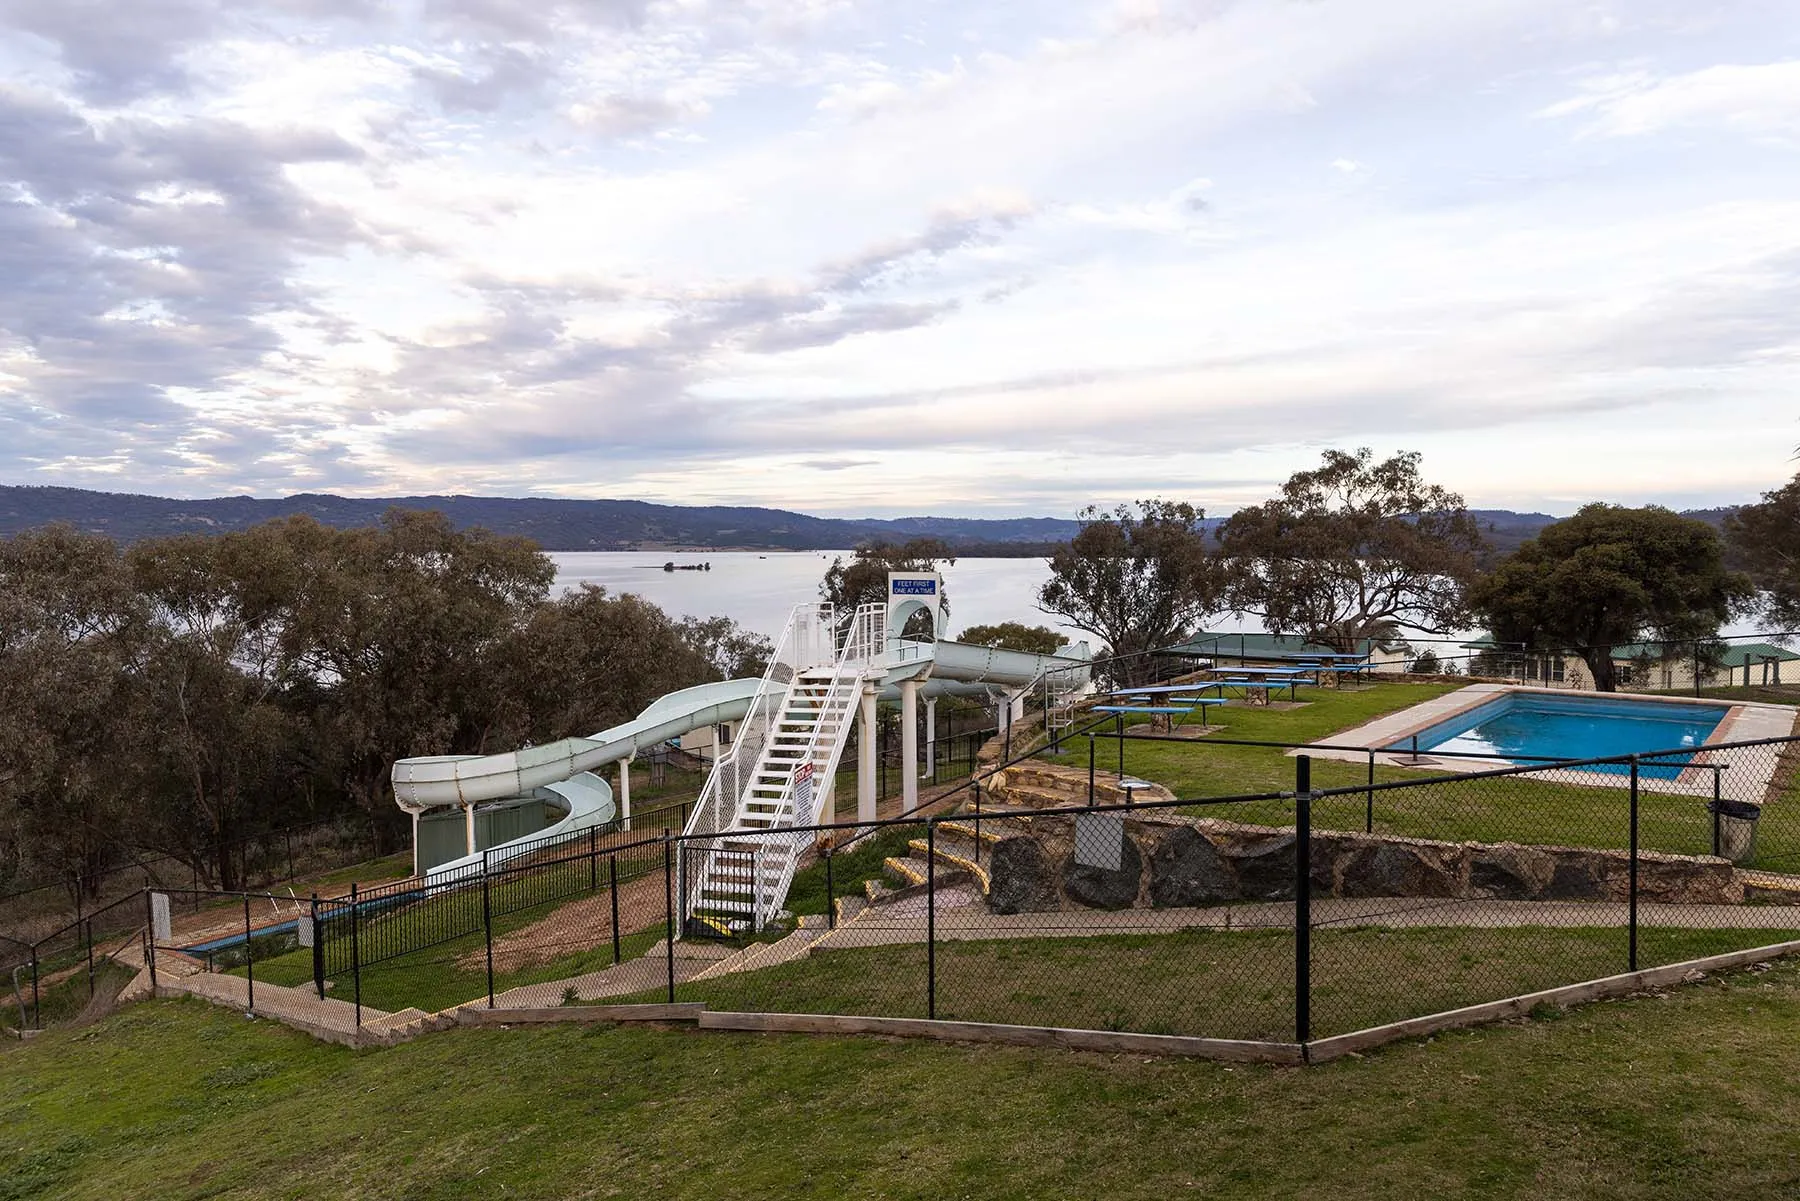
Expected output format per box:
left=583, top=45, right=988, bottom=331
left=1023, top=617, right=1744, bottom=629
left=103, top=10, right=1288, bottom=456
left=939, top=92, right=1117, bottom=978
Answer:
left=0, top=510, right=769, bottom=888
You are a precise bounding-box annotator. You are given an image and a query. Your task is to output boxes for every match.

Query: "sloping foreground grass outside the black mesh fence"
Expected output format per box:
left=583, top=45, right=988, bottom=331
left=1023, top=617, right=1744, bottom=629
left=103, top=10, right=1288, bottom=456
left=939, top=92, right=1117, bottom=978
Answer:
left=10, top=965, right=1800, bottom=1201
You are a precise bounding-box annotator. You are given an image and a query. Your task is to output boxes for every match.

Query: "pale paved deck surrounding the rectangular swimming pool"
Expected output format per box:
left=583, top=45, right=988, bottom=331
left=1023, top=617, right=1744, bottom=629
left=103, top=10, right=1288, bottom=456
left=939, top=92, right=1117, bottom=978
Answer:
left=1291, top=684, right=1800, bottom=805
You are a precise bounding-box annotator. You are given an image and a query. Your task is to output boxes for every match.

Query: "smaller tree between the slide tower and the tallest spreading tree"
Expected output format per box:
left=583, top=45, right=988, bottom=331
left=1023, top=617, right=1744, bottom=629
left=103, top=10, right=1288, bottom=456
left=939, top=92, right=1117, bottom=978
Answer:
left=1037, top=499, right=1224, bottom=675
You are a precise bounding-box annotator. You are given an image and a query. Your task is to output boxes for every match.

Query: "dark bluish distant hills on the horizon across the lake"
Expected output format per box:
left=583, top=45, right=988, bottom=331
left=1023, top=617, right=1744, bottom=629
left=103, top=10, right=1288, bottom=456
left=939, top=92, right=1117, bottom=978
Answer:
left=0, top=486, right=1733, bottom=556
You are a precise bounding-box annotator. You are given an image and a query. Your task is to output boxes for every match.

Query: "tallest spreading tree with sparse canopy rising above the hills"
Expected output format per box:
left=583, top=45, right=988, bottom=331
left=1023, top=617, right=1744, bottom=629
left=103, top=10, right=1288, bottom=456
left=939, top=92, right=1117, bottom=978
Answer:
left=1219, top=448, right=1481, bottom=652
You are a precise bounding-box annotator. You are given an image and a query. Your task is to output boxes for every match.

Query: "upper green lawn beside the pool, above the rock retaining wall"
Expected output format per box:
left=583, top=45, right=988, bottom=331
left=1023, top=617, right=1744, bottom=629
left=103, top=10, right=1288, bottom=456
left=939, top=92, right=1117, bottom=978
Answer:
left=1053, top=682, right=1800, bottom=871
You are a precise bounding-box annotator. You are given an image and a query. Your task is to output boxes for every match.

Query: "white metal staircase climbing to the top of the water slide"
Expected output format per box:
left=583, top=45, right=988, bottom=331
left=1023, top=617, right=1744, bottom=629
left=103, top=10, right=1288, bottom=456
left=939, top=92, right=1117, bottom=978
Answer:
left=677, top=605, right=886, bottom=933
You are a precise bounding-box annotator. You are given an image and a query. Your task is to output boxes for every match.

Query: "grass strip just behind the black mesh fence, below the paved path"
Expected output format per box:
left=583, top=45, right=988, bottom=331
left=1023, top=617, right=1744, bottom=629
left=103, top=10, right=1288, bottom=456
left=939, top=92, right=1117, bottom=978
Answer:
left=621, top=915, right=1796, bottom=1041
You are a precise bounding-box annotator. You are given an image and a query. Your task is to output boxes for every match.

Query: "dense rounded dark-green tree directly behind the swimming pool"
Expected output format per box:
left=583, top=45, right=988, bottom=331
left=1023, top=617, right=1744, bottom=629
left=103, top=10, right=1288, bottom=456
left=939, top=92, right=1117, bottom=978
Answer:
left=1471, top=504, right=1751, bottom=691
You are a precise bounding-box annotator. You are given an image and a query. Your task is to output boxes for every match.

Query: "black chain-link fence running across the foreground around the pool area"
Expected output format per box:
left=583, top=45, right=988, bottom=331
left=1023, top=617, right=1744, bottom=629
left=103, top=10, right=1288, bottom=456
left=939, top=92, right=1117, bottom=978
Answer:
left=24, top=727, right=1800, bottom=1043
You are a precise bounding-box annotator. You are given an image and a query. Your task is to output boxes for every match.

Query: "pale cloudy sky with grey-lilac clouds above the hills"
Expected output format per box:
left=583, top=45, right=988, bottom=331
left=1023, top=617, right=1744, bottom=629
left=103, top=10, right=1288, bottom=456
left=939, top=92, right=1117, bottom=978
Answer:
left=0, top=0, right=1800, bottom=515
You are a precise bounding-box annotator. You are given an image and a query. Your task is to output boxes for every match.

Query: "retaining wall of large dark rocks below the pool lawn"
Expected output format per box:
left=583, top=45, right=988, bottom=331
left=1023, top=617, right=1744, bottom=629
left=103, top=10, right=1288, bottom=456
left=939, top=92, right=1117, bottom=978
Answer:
left=988, top=813, right=1744, bottom=913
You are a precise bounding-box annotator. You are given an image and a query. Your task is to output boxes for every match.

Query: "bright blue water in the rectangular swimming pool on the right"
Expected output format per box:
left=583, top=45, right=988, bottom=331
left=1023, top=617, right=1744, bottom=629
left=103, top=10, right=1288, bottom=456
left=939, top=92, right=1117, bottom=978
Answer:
left=1388, top=691, right=1726, bottom=780
